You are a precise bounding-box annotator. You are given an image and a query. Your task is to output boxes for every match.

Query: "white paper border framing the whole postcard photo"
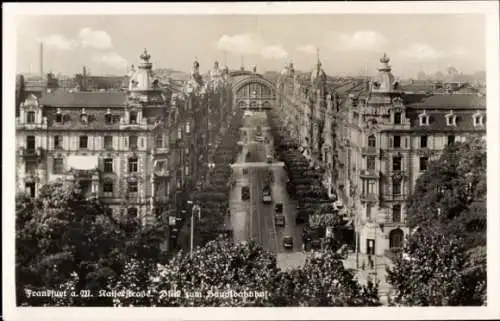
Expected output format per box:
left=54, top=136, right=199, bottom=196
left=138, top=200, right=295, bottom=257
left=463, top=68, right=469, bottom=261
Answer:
left=2, top=1, right=500, bottom=321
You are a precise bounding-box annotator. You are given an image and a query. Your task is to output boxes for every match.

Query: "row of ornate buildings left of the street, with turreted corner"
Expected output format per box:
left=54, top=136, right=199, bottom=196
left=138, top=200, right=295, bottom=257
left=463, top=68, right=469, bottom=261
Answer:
left=16, top=50, right=232, bottom=229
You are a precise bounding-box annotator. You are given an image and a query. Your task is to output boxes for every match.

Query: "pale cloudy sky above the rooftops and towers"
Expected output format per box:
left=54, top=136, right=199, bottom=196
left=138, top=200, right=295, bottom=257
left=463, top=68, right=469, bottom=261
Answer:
left=17, top=14, right=485, bottom=77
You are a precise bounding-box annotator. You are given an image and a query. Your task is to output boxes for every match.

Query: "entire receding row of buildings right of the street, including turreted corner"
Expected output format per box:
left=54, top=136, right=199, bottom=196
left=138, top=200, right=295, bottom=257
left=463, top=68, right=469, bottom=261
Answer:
left=276, top=55, right=486, bottom=255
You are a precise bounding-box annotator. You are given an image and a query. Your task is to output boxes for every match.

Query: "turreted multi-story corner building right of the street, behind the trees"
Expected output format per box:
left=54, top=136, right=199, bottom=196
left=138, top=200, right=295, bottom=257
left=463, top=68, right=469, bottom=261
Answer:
left=335, top=55, right=486, bottom=255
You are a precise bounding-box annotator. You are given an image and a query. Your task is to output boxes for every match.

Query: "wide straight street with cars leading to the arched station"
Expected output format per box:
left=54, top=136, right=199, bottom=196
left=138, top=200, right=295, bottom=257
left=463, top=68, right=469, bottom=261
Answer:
left=230, top=111, right=302, bottom=258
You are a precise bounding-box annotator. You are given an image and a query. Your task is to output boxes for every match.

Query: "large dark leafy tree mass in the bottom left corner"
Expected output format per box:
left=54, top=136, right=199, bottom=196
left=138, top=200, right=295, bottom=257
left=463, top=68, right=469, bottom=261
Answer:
left=16, top=181, right=170, bottom=306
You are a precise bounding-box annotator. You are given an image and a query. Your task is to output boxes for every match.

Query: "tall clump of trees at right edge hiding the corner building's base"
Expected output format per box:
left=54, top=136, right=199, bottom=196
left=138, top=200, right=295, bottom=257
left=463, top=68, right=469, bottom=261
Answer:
left=390, top=137, right=486, bottom=305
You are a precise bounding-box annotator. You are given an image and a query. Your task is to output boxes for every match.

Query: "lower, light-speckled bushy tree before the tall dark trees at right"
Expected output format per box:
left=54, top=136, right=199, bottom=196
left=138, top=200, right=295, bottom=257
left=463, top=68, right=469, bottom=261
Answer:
left=388, top=229, right=470, bottom=306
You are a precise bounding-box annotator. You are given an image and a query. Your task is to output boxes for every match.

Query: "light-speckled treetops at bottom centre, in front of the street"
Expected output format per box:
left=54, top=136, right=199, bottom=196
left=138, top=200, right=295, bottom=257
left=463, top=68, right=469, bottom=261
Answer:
left=113, top=239, right=380, bottom=307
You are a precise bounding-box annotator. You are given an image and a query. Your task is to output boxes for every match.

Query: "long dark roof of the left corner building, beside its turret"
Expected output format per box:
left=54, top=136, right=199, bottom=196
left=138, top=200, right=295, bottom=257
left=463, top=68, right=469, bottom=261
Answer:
left=40, top=90, right=127, bottom=108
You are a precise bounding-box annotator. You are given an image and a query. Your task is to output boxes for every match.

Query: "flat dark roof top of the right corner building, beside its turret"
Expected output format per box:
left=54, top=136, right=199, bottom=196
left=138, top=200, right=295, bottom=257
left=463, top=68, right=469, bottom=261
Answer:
left=405, top=93, right=486, bottom=109
